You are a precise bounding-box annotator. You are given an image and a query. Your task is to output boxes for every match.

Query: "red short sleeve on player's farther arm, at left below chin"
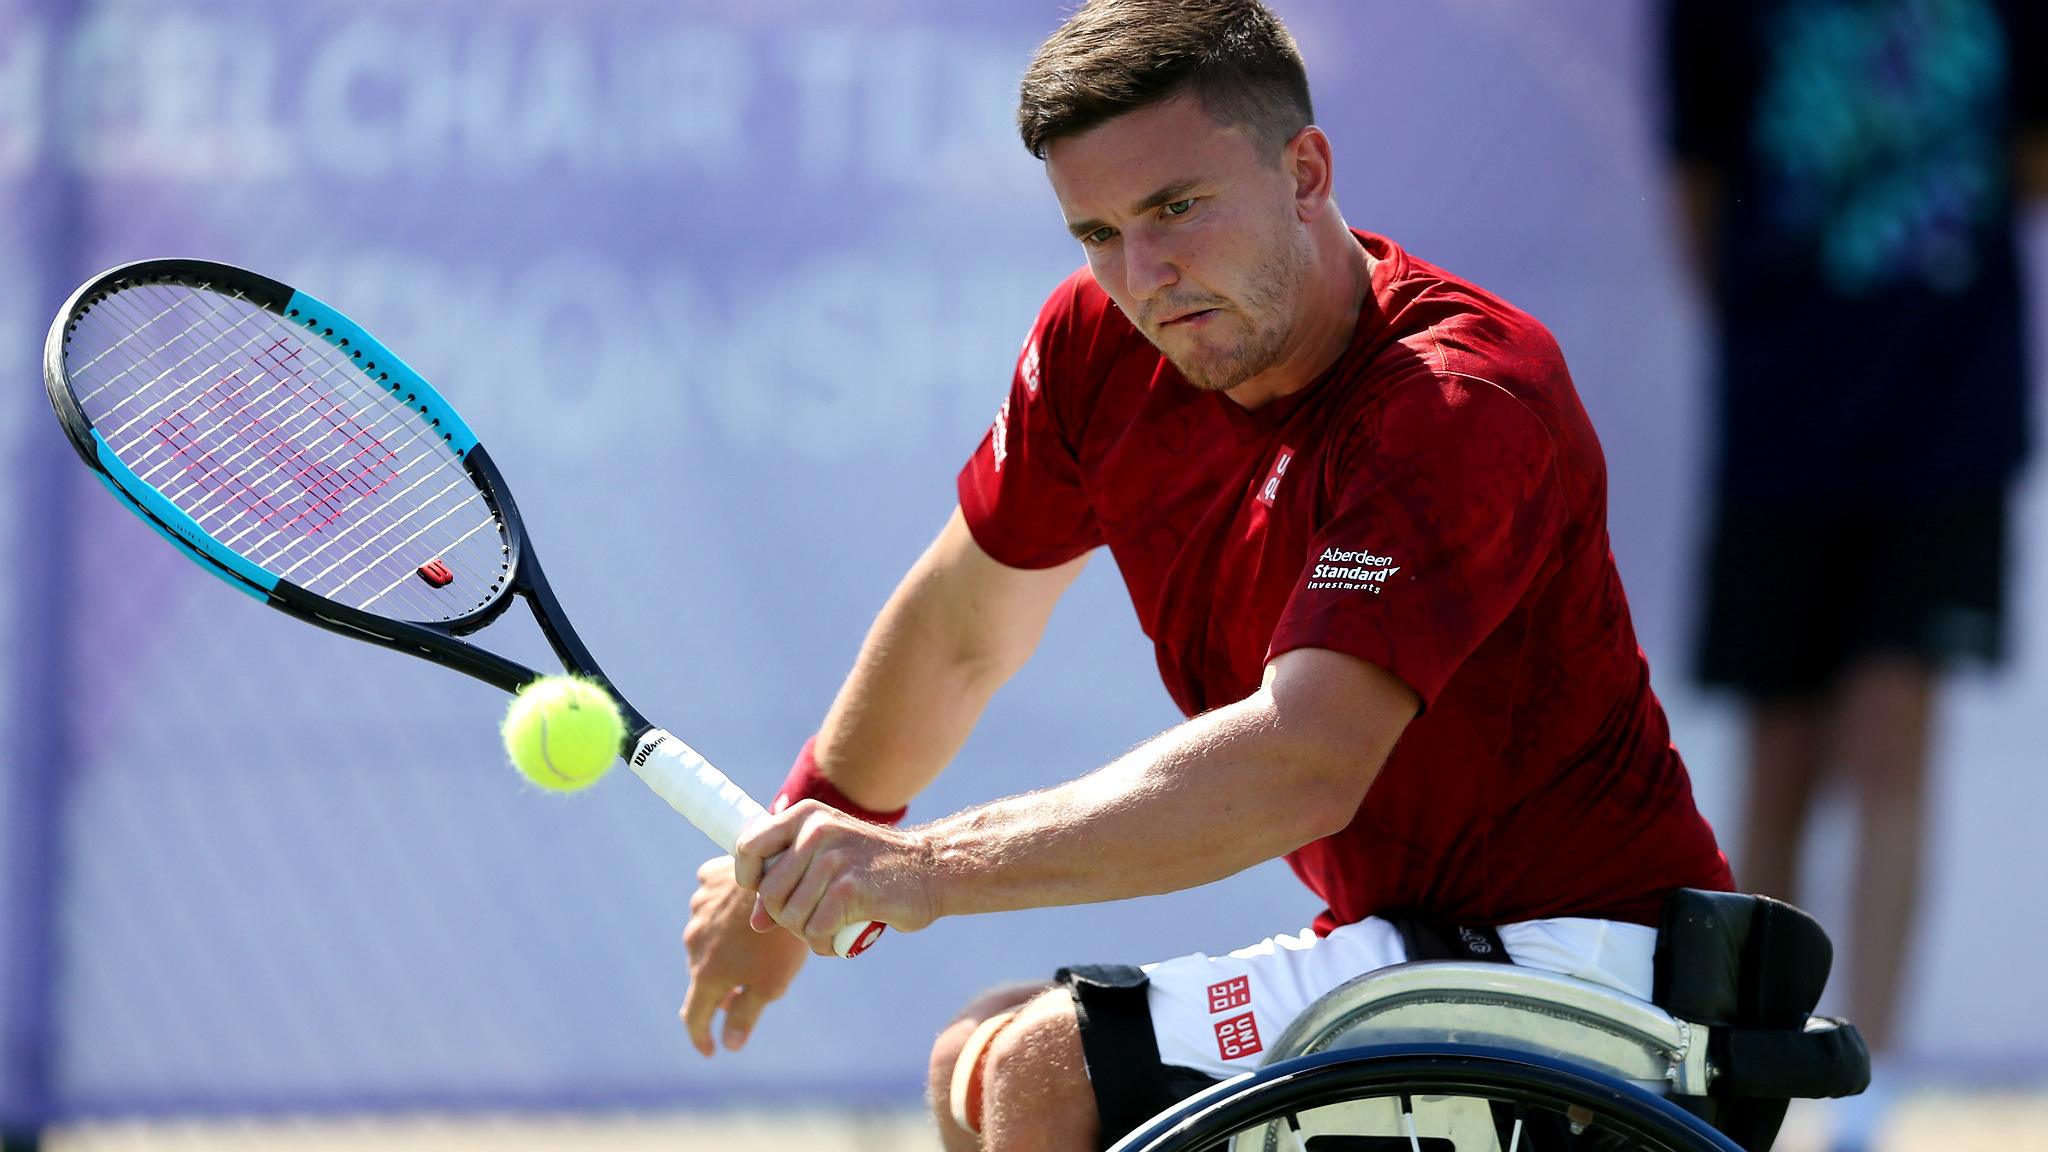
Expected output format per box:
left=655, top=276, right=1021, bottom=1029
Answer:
left=958, top=269, right=1102, bottom=568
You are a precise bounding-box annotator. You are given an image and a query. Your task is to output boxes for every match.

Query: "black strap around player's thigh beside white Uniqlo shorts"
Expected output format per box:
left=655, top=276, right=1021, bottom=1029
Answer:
left=1053, top=963, right=1180, bottom=1148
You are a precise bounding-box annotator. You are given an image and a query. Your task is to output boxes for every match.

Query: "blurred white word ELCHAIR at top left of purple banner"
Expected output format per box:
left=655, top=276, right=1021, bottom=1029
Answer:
left=44, top=10, right=756, bottom=180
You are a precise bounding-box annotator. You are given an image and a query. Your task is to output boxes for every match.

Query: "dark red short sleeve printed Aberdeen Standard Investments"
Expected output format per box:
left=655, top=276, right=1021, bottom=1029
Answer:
left=1268, top=377, right=1567, bottom=707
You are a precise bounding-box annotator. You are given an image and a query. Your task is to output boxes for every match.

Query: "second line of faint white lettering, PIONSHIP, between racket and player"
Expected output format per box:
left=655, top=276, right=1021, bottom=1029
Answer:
left=294, top=248, right=1044, bottom=461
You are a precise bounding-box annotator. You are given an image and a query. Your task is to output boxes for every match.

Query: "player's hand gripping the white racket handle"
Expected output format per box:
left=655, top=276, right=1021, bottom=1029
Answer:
left=733, top=799, right=936, bottom=955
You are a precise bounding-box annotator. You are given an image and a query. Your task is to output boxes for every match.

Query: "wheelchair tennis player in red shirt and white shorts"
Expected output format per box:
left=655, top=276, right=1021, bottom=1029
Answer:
left=682, top=0, right=1731, bottom=1148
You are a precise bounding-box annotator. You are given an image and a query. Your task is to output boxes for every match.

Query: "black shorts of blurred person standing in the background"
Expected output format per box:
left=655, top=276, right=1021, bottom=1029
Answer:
left=1698, top=494, right=2007, bottom=699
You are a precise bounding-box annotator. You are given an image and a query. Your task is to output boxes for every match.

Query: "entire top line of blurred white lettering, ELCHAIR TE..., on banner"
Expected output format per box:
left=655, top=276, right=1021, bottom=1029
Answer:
left=18, top=2, right=1036, bottom=186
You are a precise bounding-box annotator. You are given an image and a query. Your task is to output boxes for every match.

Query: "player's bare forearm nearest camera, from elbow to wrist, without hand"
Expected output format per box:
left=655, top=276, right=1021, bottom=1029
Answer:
left=918, top=664, right=1405, bottom=916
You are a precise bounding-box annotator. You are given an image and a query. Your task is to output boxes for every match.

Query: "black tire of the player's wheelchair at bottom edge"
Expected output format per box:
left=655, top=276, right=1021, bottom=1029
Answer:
left=1112, top=1043, right=1743, bottom=1152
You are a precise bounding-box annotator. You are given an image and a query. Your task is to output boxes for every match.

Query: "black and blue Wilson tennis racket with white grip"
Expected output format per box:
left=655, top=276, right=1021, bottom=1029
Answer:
left=43, top=260, right=883, bottom=955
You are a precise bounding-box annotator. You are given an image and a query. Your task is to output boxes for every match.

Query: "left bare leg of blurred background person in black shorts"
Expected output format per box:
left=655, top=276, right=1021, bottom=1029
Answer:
left=1735, top=697, right=1829, bottom=900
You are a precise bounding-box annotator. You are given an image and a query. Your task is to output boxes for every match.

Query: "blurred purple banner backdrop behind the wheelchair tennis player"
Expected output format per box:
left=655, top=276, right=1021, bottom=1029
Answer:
left=0, top=0, right=2048, bottom=1113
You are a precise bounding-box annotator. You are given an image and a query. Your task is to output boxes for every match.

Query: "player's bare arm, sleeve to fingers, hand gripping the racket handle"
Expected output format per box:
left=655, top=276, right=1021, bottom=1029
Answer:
left=733, top=648, right=1421, bottom=953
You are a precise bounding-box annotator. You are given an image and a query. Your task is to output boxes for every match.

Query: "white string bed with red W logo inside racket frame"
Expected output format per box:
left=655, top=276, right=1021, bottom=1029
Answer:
left=72, top=285, right=508, bottom=619
